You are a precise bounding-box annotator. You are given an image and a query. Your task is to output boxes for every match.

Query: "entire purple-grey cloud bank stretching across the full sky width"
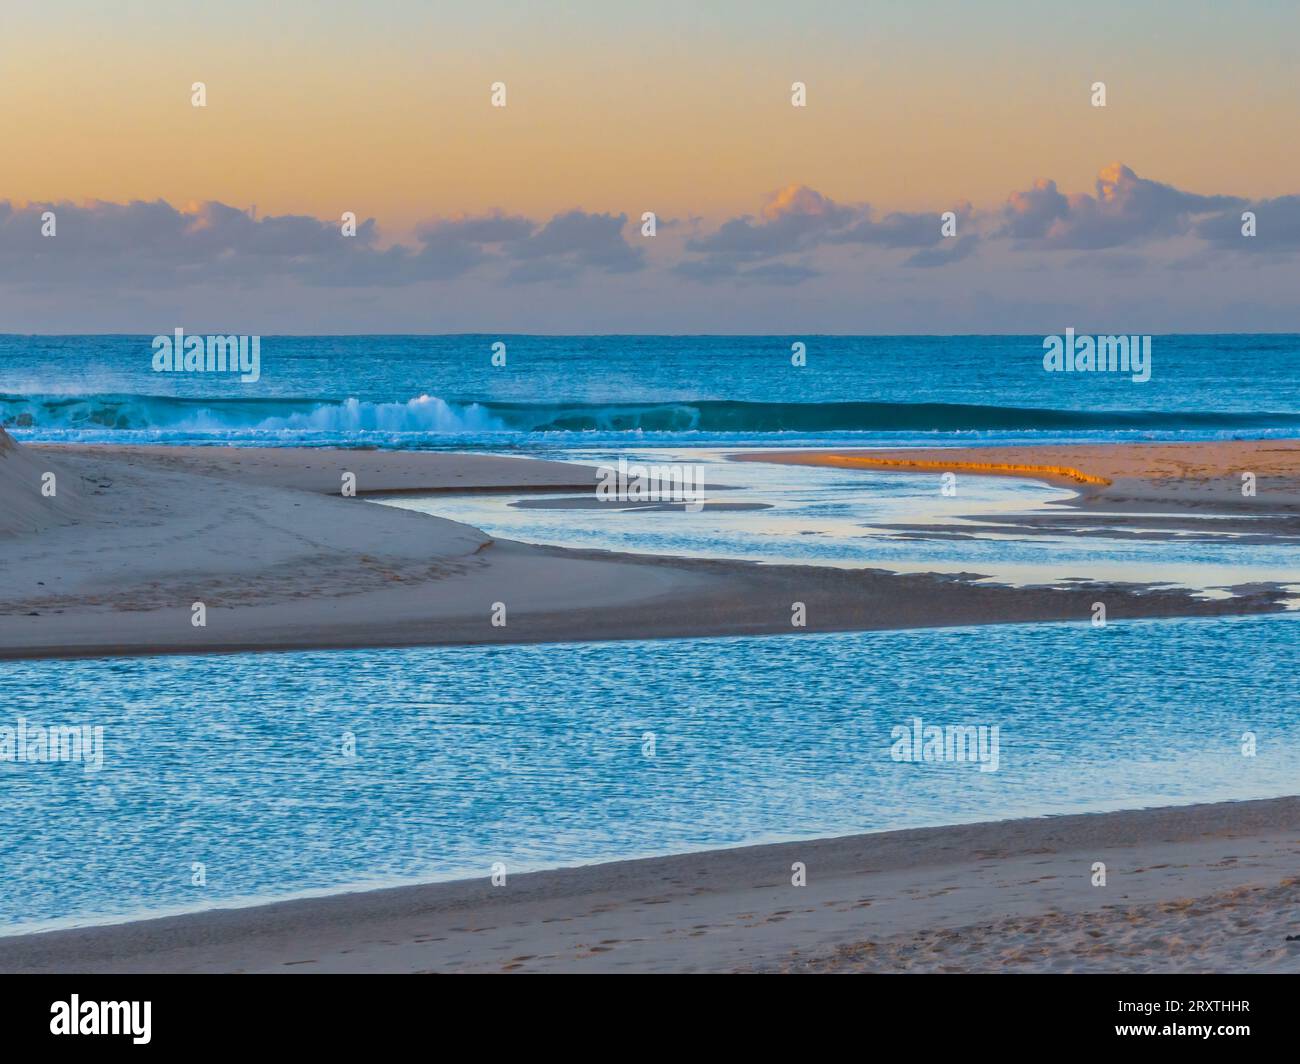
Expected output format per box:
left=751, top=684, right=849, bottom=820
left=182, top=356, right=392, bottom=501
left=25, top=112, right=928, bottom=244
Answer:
left=0, top=164, right=1300, bottom=303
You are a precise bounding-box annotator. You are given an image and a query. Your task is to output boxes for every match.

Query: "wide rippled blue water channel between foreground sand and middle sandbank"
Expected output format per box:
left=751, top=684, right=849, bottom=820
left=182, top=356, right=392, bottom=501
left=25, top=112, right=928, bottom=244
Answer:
left=0, top=615, right=1300, bottom=931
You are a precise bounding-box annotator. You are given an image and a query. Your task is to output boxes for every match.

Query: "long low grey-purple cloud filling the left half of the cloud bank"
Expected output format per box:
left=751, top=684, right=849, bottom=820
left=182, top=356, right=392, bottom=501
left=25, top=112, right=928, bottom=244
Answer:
left=0, top=200, right=645, bottom=287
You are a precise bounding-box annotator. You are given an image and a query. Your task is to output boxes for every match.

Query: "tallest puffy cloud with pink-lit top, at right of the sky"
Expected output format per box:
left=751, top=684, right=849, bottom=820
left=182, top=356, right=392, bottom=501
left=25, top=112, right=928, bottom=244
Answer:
left=996, top=163, right=1244, bottom=251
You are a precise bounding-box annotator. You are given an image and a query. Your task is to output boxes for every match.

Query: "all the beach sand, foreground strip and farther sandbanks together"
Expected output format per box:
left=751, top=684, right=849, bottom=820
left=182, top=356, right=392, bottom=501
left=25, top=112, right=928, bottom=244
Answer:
left=0, top=424, right=1300, bottom=972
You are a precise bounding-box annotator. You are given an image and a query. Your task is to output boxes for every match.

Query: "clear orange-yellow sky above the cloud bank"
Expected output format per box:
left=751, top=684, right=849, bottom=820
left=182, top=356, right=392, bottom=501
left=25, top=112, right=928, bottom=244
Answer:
left=0, top=0, right=1300, bottom=235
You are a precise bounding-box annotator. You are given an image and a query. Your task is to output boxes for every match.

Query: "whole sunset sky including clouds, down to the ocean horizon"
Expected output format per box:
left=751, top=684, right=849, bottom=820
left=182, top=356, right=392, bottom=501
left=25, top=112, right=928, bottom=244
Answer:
left=0, top=0, right=1300, bottom=334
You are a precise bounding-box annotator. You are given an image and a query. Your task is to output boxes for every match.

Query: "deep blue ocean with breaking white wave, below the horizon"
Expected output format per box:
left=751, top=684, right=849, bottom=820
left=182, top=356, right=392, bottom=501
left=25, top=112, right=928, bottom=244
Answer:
left=0, top=334, right=1300, bottom=449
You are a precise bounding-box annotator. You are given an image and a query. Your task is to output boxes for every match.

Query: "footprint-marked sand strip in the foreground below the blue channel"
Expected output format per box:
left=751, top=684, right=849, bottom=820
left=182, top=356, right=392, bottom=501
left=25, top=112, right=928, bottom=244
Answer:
left=0, top=796, right=1300, bottom=973
